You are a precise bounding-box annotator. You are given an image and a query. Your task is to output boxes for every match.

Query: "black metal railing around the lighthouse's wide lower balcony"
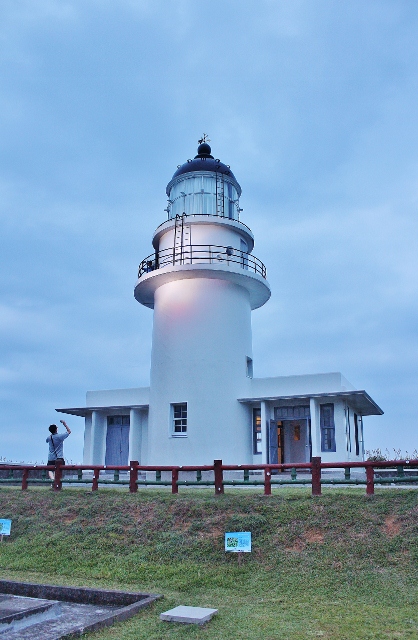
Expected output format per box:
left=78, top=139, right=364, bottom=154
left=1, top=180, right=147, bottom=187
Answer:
left=138, top=244, right=267, bottom=278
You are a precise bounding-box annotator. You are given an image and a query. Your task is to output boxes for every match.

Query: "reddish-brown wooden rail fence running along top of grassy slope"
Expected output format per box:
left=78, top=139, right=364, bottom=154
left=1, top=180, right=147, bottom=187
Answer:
left=0, top=457, right=418, bottom=496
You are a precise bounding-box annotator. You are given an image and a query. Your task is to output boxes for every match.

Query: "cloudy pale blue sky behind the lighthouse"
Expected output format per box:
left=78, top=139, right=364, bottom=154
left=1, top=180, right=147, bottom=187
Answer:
left=0, top=0, right=418, bottom=463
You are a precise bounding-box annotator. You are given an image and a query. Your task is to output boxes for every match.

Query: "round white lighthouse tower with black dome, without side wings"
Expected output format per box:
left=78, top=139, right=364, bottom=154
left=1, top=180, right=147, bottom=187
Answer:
left=135, top=138, right=270, bottom=465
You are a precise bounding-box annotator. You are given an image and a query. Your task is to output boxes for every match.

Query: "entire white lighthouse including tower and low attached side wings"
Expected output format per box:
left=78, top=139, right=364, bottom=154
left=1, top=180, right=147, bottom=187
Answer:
left=58, top=142, right=383, bottom=465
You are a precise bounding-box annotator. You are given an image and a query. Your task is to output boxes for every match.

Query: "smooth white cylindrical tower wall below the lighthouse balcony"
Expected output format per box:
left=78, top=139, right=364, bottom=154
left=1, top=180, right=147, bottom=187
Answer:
left=148, top=278, right=252, bottom=464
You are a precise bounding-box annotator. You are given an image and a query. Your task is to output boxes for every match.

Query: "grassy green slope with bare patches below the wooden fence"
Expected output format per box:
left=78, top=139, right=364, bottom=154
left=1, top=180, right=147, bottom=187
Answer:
left=0, top=487, right=418, bottom=640
